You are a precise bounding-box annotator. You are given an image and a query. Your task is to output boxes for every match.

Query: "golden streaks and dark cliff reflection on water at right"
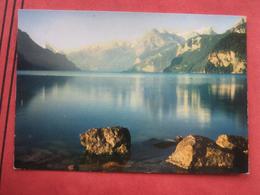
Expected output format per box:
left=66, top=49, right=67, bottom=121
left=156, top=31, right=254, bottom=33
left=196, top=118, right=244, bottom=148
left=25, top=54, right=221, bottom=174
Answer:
left=176, top=78, right=247, bottom=123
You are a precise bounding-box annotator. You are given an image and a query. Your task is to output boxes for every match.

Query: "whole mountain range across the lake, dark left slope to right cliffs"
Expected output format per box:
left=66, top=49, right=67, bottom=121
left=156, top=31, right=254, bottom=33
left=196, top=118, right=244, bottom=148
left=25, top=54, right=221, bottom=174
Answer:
left=18, top=18, right=247, bottom=74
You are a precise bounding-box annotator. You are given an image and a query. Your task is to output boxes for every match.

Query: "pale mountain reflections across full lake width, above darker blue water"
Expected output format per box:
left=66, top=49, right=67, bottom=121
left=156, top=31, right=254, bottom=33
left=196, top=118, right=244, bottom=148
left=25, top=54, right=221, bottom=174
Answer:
left=17, top=74, right=247, bottom=131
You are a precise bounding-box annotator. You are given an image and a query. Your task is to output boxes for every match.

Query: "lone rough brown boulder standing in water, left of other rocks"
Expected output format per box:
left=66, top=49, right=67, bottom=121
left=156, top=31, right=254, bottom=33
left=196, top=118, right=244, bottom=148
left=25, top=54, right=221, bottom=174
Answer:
left=80, top=127, right=131, bottom=155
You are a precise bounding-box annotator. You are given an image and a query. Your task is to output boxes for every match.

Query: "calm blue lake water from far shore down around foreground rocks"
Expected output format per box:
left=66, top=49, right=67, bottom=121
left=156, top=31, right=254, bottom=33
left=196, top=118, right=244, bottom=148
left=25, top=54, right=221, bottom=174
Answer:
left=15, top=71, right=247, bottom=172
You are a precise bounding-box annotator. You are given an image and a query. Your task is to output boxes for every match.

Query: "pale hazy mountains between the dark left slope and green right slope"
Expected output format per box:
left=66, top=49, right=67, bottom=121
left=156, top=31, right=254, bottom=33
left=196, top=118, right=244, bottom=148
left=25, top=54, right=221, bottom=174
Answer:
left=67, top=29, right=184, bottom=72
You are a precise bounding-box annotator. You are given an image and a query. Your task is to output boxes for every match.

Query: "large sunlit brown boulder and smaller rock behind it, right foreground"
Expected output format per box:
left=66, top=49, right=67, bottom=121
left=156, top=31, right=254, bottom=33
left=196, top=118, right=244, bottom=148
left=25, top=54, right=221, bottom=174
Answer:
left=166, top=135, right=247, bottom=169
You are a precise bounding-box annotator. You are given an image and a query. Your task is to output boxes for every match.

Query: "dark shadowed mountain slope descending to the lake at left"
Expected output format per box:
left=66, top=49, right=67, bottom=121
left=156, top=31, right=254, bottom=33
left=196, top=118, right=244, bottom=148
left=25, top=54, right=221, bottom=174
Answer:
left=18, top=30, right=79, bottom=70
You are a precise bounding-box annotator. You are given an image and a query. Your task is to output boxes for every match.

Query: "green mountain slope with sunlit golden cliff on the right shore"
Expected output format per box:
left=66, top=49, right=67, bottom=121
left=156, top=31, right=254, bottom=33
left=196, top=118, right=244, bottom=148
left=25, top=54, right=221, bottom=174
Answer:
left=164, top=19, right=246, bottom=74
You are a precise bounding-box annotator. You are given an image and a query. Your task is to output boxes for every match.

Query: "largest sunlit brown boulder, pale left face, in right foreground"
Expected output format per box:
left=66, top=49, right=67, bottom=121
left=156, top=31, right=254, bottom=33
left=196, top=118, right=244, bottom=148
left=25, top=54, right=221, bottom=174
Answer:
left=166, top=135, right=234, bottom=169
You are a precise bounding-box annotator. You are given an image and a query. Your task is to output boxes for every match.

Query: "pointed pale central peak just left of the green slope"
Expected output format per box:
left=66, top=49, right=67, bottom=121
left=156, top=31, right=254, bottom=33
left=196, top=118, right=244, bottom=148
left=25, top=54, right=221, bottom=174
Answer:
left=129, top=29, right=184, bottom=72
